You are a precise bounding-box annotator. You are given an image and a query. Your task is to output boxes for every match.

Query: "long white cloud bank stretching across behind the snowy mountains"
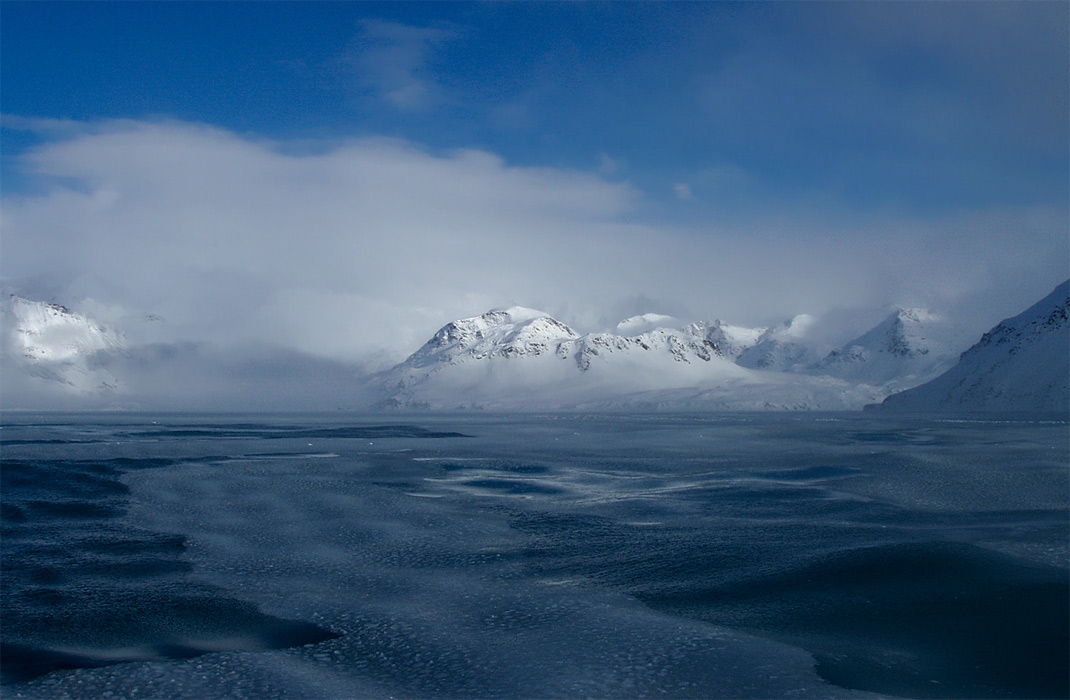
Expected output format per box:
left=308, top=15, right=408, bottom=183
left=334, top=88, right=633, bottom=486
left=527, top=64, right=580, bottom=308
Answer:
left=0, top=121, right=1067, bottom=372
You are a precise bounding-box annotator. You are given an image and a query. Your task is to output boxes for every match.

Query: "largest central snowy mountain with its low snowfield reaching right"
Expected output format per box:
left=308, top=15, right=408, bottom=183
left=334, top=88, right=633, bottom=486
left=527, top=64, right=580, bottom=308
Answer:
left=379, top=307, right=883, bottom=410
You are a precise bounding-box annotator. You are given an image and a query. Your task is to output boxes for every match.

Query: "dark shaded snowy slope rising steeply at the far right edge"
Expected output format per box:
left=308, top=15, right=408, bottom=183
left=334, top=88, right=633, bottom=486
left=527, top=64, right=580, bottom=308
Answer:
left=882, top=280, right=1070, bottom=411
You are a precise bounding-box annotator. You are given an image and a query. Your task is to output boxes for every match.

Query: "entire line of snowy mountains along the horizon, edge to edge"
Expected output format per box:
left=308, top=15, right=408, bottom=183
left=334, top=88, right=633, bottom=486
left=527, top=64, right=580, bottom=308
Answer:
left=0, top=281, right=1070, bottom=411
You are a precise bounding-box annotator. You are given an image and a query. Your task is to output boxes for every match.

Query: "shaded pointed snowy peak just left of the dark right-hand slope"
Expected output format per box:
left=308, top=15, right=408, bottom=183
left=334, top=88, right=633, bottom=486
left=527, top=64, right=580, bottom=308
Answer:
left=809, top=308, right=953, bottom=390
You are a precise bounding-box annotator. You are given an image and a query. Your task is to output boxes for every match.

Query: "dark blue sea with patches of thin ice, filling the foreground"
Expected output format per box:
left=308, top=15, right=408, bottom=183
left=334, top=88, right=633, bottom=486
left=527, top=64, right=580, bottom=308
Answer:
left=0, top=413, right=1070, bottom=700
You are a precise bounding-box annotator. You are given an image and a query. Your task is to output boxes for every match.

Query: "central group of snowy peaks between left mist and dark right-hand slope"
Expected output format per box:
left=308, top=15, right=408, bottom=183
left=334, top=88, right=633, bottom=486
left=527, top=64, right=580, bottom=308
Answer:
left=377, top=307, right=951, bottom=410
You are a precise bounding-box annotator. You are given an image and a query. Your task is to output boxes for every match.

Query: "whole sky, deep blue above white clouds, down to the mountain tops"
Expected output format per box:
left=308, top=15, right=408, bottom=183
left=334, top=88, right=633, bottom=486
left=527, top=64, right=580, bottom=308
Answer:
left=0, top=2, right=1070, bottom=359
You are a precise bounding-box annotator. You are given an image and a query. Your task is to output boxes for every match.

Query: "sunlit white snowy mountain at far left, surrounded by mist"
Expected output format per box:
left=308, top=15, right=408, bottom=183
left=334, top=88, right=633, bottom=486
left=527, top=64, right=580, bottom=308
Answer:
left=2, top=295, right=125, bottom=394
